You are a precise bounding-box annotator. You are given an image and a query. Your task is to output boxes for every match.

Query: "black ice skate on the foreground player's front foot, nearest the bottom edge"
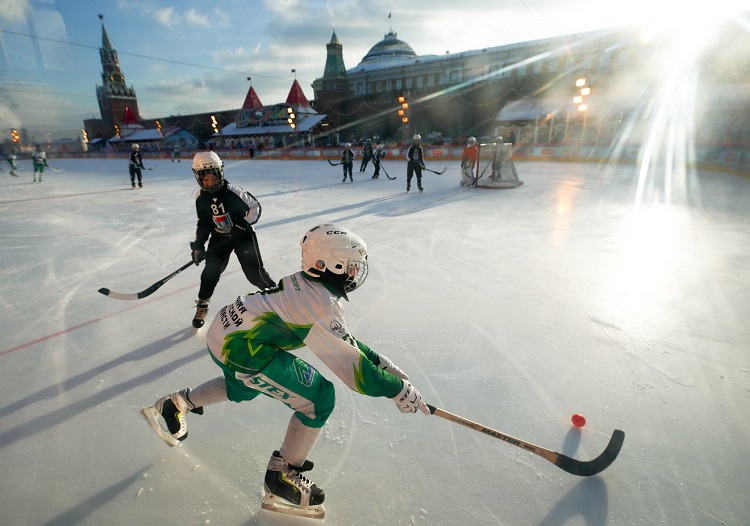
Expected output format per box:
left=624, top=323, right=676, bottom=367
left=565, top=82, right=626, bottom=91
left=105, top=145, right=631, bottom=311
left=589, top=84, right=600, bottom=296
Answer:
left=261, top=451, right=325, bottom=519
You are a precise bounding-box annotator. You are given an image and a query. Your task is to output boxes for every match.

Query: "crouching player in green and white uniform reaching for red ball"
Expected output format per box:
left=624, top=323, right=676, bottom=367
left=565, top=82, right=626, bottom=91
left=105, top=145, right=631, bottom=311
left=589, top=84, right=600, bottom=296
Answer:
left=141, top=224, right=429, bottom=518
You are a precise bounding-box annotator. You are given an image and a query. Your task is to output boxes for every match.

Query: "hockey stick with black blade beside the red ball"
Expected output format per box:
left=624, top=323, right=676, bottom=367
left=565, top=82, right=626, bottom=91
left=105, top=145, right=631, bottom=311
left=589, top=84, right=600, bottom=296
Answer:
left=427, top=404, right=625, bottom=477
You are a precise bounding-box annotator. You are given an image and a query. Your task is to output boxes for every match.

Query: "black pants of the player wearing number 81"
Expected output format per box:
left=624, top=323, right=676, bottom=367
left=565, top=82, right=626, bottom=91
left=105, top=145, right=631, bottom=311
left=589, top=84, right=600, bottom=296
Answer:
left=198, top=235, right=276, bottom=300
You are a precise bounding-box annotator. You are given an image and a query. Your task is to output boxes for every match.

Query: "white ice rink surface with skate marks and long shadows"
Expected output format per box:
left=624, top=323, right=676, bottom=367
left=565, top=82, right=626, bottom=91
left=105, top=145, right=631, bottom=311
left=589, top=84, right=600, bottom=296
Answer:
left=0, top=159, right=750, bottom=526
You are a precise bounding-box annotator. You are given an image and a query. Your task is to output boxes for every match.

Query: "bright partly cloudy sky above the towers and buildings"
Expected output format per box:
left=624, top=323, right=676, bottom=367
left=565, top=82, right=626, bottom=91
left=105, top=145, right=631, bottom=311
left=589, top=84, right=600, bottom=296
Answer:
left=0, top=0, right=740, bottom=137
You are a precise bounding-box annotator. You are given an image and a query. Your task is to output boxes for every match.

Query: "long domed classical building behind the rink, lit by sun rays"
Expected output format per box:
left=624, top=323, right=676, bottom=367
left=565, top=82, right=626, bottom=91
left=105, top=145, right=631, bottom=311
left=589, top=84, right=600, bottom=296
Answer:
left=312, top=24, right=750, bottom=146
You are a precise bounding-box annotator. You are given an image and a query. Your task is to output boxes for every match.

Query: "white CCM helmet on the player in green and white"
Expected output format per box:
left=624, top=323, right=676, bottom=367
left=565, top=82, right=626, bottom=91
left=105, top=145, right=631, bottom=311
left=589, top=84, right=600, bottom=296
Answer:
left=299, top=223, right=368, bottom=296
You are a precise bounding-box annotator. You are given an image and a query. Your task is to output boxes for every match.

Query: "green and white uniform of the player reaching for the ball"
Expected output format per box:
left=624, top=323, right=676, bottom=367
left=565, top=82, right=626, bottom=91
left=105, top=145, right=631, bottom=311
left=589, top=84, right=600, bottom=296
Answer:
left=206, top=272, right=404, bottom=428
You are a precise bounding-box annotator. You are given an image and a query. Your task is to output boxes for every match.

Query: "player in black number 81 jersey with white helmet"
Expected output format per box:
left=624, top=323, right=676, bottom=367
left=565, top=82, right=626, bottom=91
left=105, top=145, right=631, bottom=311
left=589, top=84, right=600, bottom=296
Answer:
left=190, top=152, right=276, bottom=329
